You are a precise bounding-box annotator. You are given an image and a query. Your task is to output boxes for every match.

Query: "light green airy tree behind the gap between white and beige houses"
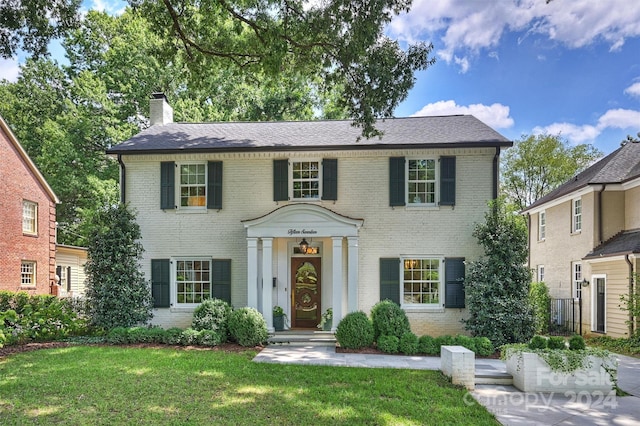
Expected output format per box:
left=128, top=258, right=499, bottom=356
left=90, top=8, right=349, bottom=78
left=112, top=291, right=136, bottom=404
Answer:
left=501, top=134, right=602, bottom=210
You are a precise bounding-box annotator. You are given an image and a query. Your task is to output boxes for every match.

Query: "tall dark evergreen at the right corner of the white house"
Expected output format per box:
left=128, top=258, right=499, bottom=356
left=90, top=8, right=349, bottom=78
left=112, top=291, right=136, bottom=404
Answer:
left=464, top=199, right=535, bottom=347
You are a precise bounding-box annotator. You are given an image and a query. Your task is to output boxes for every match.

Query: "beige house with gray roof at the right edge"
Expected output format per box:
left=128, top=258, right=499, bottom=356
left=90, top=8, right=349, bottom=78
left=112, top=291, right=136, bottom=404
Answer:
left=523, top=142, right=640, bottom=337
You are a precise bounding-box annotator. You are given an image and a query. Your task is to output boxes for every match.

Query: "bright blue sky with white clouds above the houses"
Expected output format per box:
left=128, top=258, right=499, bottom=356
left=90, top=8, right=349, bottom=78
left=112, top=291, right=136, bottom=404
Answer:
left=0, top=0, right=640, bottom=153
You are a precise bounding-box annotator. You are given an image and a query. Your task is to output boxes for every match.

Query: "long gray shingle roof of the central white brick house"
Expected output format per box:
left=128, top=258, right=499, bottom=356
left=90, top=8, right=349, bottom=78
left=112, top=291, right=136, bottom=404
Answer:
left=107, top=115, right=512, bottom=154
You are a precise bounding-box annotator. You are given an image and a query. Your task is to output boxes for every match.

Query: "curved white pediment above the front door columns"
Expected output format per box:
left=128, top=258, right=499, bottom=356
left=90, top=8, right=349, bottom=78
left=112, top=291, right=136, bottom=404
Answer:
left=242, top=203, right=364, bottom=238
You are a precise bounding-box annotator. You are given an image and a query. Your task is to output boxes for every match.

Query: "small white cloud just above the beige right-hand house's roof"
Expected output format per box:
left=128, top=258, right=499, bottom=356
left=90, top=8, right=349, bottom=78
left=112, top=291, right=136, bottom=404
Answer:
left=533, top=109, right=640, bottom=144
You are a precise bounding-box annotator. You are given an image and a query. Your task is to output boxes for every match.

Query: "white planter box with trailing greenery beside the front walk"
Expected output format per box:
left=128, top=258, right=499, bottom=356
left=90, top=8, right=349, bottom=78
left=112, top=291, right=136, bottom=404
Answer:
left=507, top=352, right=617, bottom=393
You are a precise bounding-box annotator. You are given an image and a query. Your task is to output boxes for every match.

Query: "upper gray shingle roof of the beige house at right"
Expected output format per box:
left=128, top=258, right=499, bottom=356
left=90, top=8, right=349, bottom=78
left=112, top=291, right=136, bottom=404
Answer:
left=523, top=142, right=640, bottom=212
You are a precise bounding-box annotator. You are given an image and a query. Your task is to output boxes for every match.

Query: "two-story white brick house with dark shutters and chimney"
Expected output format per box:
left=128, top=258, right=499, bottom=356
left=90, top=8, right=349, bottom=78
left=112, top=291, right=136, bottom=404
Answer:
left=108, top=94, right=512, bottom=335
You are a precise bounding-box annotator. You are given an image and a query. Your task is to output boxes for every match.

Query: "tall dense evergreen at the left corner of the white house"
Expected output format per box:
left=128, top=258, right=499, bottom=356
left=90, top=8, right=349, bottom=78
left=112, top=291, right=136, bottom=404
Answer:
left=86, top=204, right=153, bottom=329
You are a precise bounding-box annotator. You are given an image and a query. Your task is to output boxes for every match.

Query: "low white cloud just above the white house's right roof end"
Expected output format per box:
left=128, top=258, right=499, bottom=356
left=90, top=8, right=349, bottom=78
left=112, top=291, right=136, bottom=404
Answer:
left=412, top=100, right=513, bottom=129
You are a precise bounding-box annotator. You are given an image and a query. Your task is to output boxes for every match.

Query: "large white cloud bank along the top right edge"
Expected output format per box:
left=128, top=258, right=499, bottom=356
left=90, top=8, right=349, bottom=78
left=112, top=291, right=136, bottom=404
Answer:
left=389, top=0, right=640, bottom=71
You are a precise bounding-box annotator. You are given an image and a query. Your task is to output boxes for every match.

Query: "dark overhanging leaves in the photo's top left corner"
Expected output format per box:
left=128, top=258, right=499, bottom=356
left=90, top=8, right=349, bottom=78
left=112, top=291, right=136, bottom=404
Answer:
left=0, top=0, right=82, bottom=58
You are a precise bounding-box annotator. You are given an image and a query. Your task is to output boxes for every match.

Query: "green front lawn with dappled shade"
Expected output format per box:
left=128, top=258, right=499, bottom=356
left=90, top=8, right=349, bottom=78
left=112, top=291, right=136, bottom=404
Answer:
left=0, top=346, right=498, bottom=425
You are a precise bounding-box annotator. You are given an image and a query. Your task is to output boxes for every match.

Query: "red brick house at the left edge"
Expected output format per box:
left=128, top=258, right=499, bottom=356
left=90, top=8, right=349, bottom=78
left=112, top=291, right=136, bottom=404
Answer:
left=0, top=117, right=59, bottom=294
